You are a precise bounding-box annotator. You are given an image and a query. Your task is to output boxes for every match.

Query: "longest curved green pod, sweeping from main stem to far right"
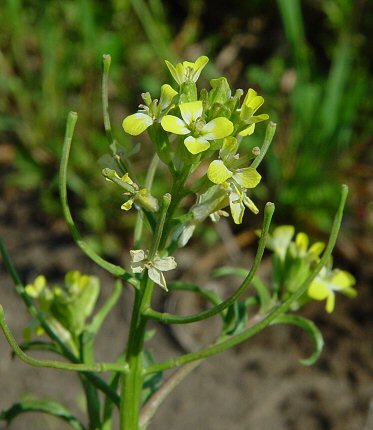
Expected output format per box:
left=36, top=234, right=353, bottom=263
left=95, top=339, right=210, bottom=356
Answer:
left=145, top=185, right=348, bottom=374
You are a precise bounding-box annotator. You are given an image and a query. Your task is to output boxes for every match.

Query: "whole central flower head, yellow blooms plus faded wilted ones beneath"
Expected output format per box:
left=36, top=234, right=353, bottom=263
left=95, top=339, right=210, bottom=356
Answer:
left=103, top=56, right=269, bottom=289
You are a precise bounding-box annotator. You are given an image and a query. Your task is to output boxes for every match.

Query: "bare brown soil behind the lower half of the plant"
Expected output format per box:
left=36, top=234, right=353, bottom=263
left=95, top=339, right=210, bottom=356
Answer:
left=0, top=182, right=373, bottom=430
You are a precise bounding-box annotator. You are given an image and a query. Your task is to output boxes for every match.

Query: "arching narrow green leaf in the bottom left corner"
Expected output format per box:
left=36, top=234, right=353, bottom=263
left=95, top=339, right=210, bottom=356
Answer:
left=0, top=398, right=85, bottom=430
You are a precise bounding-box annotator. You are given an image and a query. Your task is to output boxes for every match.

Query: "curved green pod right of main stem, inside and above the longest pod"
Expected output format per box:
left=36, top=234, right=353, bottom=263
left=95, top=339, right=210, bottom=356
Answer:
left=145, top=203, right=275, bottom=324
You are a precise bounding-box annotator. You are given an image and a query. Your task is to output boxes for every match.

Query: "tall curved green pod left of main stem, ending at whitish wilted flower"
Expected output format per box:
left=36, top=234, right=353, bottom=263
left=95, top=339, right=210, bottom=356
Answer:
left=59, top=112, right=138, bottom=287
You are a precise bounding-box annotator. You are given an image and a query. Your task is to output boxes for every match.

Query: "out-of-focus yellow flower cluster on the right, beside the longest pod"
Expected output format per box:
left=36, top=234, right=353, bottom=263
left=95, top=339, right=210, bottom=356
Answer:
left=267, top=225, right=356, bottom=313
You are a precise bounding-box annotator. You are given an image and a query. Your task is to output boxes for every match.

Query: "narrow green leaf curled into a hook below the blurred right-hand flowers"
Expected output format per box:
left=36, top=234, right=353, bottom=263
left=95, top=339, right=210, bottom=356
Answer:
left=271, top=315, right=324, bottom=366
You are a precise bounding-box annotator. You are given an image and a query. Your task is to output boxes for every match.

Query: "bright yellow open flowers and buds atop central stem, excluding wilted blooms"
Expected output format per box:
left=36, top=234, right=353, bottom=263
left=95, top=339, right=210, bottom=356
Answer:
left=119, top=56, right=268, bottom=228
